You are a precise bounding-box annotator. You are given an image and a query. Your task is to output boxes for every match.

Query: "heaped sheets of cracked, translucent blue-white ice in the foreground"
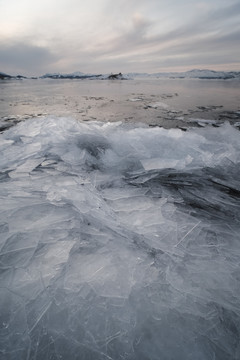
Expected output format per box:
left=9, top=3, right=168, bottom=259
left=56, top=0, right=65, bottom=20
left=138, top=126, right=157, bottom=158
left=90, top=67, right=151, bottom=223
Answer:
left=0, top=117, right=240, bottom=360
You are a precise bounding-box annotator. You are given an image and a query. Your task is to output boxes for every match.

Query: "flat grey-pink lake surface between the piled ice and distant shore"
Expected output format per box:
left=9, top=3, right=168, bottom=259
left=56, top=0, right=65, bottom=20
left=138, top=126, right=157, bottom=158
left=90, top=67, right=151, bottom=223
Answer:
left=0, top=79, right=240, bottom=128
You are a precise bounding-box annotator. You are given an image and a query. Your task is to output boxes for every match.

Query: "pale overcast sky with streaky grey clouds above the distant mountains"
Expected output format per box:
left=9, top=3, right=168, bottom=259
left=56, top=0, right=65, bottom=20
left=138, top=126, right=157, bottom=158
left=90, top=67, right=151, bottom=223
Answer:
left=0, top=0, right=240, bottom=76
